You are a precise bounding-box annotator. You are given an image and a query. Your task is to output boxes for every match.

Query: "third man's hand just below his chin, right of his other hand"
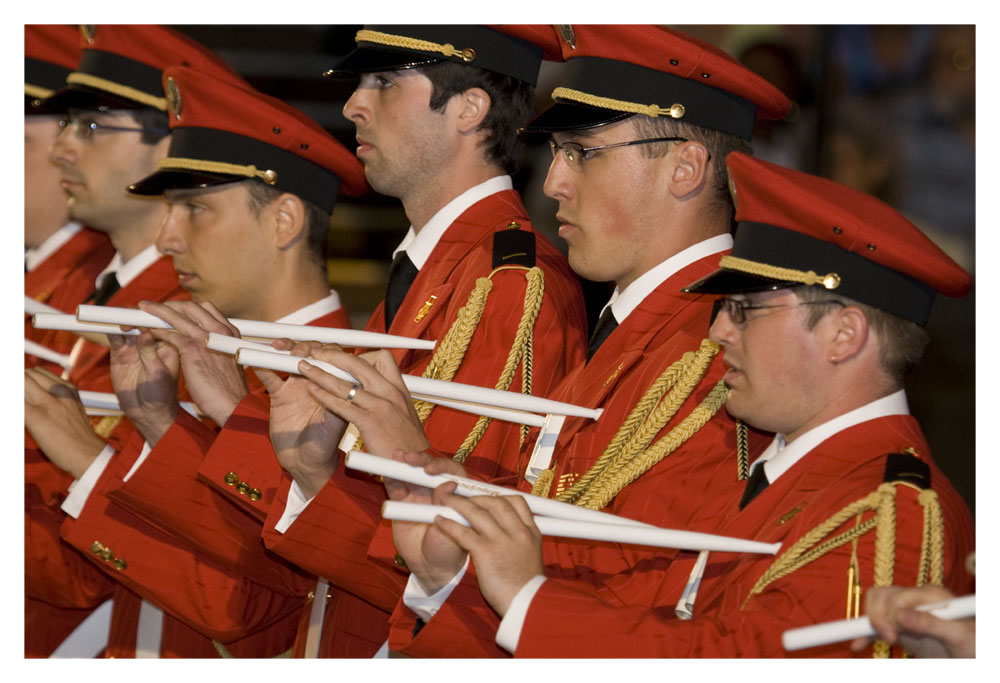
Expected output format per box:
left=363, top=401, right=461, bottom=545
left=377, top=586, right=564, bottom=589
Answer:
left=139, top=301, right=248, bottom=426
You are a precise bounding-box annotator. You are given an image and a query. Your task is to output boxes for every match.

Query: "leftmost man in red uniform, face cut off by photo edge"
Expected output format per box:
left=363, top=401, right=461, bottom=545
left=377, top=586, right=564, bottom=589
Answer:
left=24, top=24, right=114, bottom=657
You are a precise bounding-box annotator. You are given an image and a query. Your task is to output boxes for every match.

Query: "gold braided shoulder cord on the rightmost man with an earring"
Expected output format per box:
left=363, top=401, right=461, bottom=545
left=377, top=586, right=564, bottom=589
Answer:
left=740, top=481, right=944, bottom=658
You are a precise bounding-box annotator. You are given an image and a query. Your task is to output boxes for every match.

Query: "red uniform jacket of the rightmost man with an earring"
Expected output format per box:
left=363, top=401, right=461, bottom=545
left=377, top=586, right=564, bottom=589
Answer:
left=512, top=416, right=974, bottom=657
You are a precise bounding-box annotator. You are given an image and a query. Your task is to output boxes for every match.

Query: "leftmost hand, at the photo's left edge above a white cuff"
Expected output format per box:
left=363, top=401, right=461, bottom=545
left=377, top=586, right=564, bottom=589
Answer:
left=24, top=368, right=106, bottom=479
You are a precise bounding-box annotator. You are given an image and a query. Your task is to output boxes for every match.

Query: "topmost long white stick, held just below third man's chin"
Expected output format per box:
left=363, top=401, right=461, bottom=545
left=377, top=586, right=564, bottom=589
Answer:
left=76, top=304, right=436, bottom=349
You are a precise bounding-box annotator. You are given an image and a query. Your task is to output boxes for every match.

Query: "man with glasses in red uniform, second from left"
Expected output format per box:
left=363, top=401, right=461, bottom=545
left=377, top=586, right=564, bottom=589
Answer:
left=25, top=26, right=286, bottom=656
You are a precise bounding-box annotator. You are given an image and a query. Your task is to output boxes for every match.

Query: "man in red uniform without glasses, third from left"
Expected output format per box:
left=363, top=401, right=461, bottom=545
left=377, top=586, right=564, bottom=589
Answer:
left=47, top=67, right=368, bottom=654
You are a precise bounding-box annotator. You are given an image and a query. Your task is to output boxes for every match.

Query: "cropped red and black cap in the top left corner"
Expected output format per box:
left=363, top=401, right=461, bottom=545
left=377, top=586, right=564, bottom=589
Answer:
left=24, top=24, right=80, bottom=114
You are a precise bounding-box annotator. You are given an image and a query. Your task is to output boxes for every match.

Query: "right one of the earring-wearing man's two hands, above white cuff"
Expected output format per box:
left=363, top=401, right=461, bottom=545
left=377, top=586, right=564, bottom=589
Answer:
left=434, top=487, right=544, bottom=617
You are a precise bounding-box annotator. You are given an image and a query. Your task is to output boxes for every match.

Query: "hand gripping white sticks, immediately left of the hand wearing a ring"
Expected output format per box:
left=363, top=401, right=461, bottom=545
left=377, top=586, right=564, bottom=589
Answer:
left=254, top=339, right=347, bottom=498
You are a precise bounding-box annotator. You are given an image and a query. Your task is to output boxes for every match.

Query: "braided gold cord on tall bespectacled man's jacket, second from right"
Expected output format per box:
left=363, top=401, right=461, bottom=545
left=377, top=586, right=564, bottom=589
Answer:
left=532, top=339, right=727, bottom=510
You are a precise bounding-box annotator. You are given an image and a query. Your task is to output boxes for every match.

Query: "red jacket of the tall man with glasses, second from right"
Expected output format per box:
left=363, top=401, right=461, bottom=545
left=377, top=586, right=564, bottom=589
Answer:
left=378, top=254, right=764, bottom=657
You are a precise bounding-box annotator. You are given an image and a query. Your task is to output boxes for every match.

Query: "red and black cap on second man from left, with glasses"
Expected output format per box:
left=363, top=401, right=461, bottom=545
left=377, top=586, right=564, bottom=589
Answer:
left=43, top=24, right=244, bottom=112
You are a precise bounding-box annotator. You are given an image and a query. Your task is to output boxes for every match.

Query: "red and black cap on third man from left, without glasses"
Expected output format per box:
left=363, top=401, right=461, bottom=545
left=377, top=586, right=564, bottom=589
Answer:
left=128, top=66, right=367, bottom=211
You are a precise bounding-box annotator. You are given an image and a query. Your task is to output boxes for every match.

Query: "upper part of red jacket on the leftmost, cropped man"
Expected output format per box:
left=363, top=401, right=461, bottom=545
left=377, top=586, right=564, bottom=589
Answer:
left=24, top=228, right=115, bottom=356
